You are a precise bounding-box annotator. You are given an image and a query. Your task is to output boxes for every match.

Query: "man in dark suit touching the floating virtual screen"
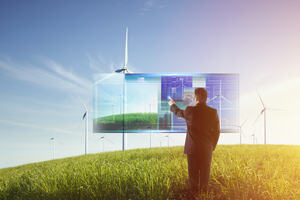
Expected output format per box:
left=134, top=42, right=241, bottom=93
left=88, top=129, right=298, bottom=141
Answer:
left=169, top=88, right=220, bottom=193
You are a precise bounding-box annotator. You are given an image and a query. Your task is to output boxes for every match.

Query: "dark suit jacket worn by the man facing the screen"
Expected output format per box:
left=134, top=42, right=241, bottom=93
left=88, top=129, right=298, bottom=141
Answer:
left=170, top=103, right=220, bottom=154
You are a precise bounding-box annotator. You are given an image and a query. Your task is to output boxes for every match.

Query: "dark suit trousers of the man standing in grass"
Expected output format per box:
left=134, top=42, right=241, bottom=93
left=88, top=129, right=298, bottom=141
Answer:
left=187, top=148, right=213, bottom=191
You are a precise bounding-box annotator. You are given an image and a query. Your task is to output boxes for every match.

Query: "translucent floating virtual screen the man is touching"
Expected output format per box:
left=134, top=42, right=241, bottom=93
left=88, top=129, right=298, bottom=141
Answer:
left=93, top=73, right=239, bottom=133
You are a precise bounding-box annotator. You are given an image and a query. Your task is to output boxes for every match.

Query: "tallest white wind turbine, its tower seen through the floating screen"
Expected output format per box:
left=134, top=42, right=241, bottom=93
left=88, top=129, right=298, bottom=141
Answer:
left=115, top=27, right=129, bottom=151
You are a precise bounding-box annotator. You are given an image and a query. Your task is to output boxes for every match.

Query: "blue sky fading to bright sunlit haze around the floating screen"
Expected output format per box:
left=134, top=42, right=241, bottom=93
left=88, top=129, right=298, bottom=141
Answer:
left=0, top=0, right=300, bottom=168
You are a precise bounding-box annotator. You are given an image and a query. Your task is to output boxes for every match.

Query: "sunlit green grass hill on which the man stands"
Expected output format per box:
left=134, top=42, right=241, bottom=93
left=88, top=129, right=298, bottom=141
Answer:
left=0, top=145, right=300, bottom=200
